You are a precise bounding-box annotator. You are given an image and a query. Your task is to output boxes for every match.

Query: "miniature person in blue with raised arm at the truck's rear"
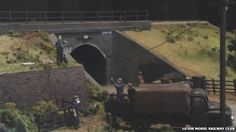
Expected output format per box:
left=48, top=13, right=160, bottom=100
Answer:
left=111, top=77, right=125, bottom=102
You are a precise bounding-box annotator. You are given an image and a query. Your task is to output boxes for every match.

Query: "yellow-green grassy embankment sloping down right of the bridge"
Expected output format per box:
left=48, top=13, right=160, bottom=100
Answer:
left=121, top=23, right=236, bottom=79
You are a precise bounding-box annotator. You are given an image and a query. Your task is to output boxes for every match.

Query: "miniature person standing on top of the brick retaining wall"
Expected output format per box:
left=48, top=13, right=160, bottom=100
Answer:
left=55, top=35, right=66, bottom=65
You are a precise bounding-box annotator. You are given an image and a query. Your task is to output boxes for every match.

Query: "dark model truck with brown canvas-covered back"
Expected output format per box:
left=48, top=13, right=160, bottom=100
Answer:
left=105, top=83, right=232, bottom=127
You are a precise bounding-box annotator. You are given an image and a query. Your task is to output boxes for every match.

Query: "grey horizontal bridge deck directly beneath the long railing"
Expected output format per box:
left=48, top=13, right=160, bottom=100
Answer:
left=0, top=20, right=151, bottom=33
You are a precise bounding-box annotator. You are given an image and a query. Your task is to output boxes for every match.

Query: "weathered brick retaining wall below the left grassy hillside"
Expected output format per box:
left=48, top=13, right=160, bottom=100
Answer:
left=0, top=66, right=88, bottom=106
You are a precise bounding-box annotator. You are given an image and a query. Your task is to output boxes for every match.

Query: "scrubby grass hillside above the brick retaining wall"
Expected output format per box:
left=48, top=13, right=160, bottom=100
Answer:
left=0, top=31, right=78, bottom=74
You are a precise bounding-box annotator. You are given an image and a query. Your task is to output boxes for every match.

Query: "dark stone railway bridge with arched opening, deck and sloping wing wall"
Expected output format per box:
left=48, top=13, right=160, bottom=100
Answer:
left=0, top=20, right=184, bottom=85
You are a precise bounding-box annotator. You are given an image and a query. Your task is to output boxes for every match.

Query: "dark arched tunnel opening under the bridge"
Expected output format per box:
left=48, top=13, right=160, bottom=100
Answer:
left=71, top=44, right=106, bottom=85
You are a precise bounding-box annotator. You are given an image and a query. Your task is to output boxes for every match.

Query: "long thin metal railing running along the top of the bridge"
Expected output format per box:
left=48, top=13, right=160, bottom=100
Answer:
left=0, top=10, right=149, bottom=23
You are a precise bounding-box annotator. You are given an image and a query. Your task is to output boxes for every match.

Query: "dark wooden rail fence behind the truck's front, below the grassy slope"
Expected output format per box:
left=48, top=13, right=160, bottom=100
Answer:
left=206, top=79, right=236, bottom=94
